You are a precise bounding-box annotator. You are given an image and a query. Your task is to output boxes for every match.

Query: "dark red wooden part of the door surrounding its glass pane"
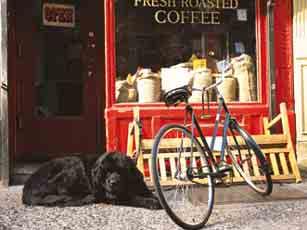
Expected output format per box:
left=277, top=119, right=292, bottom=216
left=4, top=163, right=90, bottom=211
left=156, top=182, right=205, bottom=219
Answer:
left=9, top=0, right=105, bottom=158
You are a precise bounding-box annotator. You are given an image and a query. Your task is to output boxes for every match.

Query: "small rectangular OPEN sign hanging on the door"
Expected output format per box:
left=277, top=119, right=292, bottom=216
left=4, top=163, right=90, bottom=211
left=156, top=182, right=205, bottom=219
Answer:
left=43, top=3, right=75, bottom=27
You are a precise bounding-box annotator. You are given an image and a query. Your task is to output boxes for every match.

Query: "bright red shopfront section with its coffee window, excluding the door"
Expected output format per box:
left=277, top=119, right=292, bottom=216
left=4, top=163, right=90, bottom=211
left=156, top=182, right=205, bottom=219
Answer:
left=105, top=0, right=295, bottom=154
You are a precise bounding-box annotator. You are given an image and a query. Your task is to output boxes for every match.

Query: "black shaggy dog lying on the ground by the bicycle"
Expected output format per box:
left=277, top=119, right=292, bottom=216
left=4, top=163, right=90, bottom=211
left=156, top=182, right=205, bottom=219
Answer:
left=22, top=153, right=161, bottom=209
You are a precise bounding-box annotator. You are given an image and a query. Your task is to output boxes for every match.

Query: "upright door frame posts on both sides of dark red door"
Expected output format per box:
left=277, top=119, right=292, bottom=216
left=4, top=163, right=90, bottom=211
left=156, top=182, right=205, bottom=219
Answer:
left=4, top=0, right=106, bottom=183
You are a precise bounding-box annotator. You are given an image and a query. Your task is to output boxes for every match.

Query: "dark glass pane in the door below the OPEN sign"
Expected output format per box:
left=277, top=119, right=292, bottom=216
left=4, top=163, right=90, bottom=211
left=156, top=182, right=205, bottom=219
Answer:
left=35, top=2, right=84, bottom=117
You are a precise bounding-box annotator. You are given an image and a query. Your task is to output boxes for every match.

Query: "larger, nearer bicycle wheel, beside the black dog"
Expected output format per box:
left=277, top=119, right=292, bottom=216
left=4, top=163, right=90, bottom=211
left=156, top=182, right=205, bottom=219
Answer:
left=152, top=124, right=214, bottom=229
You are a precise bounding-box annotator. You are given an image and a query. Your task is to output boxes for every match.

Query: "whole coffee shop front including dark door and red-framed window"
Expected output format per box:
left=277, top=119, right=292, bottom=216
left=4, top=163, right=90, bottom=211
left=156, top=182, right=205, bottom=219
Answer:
left=0, top=0, right=295, bottom=185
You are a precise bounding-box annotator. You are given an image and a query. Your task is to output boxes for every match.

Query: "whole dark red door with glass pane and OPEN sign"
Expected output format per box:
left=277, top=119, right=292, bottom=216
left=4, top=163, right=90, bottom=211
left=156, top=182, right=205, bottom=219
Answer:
left=13, top=0, right=104, bottom=158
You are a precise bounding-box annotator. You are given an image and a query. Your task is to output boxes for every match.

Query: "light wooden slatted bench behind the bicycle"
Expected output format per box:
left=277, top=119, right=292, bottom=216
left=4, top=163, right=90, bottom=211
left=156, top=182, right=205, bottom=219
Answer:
left=127, top=103, right=302, bottom=185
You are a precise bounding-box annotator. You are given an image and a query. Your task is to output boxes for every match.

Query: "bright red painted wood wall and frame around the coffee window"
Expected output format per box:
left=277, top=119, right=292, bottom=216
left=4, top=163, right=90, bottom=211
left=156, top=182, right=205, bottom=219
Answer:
left=105, top=0, right=295, bottom=152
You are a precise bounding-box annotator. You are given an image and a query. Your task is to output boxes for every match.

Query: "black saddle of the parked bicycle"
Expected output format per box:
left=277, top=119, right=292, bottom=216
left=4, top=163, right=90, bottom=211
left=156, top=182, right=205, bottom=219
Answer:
left=163, top=86, right=191, bottom=106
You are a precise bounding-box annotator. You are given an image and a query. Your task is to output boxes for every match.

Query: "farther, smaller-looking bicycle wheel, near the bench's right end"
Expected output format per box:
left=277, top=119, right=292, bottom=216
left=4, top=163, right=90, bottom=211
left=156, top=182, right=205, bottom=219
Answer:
left=227, top=120, right=273, bottom=196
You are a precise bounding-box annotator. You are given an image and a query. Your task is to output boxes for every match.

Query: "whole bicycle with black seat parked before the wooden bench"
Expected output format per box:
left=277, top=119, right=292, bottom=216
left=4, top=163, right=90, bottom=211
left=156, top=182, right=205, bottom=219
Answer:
left=151, top=65, right=273, bottom=229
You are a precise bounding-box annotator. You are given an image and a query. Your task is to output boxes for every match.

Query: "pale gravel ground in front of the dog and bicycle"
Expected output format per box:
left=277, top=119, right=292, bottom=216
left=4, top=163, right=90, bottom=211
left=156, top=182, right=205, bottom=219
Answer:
left=0, top=186, right=307, bottom=230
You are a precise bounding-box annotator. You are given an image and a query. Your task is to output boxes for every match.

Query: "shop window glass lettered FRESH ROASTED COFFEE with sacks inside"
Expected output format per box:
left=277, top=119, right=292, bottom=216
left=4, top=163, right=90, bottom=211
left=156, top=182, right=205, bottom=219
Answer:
left=114, top=0, right=259, bottom=103
